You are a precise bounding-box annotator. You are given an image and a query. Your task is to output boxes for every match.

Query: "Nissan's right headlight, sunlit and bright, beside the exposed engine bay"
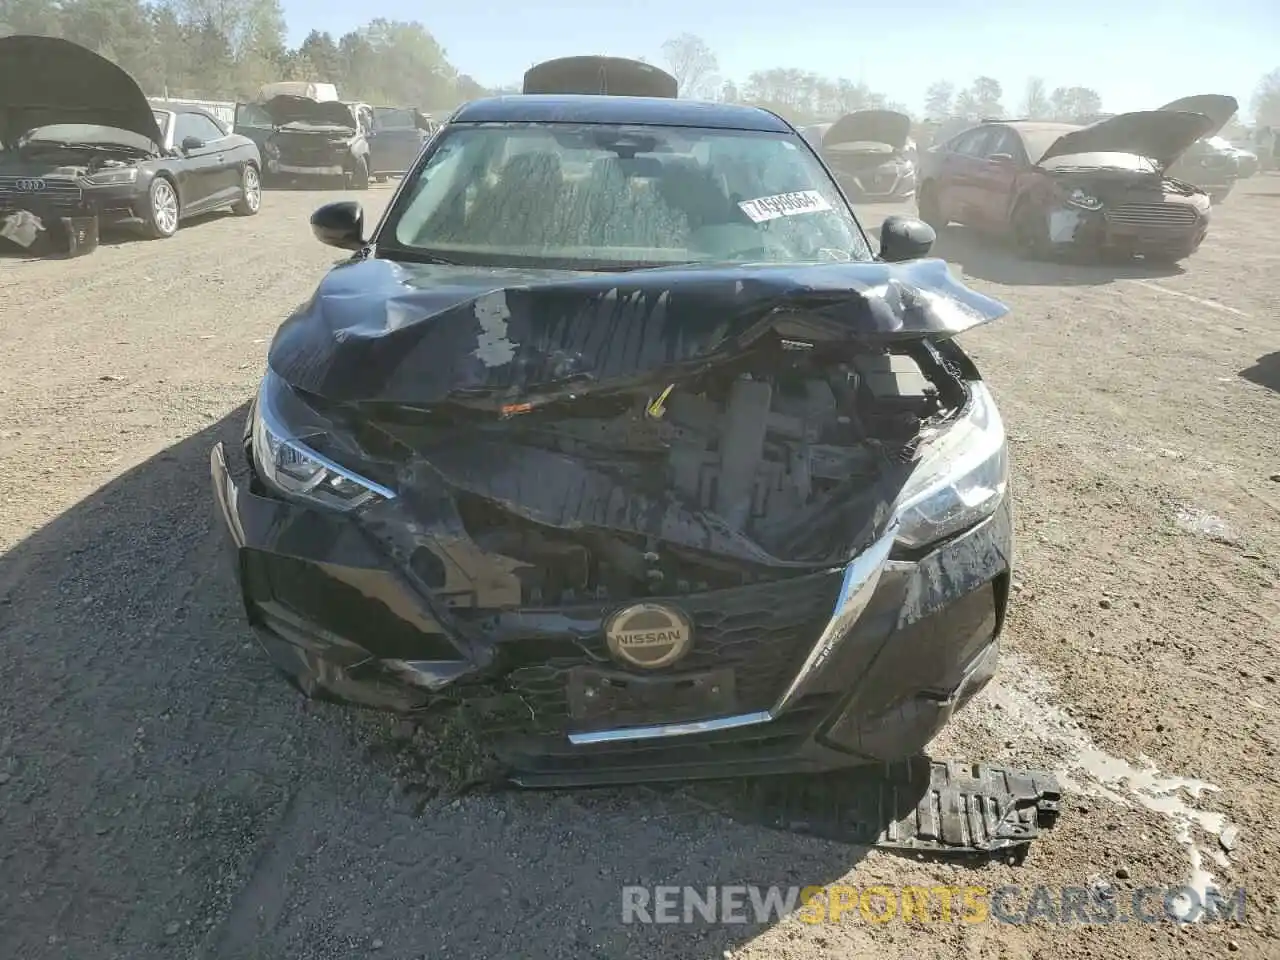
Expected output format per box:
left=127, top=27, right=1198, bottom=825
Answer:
left=895, top=383, right=1009, bottom=549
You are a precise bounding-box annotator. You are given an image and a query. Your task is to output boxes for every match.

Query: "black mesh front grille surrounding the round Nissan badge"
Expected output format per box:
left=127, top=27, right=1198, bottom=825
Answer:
left=465, top=571, right=842, bottom=732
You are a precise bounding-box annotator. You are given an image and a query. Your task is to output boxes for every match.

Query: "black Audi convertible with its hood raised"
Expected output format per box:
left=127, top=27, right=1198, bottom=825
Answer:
left=0, top=36, right=261, bottom=255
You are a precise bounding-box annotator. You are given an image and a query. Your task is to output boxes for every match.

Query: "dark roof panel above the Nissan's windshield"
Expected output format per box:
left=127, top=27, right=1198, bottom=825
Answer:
left=449, top=93, right=794, bottom=133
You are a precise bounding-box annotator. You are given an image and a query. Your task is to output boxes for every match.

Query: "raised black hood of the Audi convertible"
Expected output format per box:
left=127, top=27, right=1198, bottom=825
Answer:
left=0, top=35, right=164, bottom=146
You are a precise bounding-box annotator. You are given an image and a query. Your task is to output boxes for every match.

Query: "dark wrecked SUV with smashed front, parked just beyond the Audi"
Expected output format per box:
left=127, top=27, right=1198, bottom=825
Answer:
left=249, top=93, right=372, bottom=189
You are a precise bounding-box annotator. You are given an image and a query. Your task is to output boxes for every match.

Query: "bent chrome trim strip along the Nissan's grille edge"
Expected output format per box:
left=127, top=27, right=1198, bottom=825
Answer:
left=568, top=520, right=897, bottom=746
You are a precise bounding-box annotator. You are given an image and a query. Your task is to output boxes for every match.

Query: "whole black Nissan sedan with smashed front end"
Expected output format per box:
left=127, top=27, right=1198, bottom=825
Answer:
left=211, top=84, right=1011, bottom=786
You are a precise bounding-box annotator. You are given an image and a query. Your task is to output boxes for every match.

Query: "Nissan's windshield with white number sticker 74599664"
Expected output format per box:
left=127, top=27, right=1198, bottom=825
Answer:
left=388, top=124, right=872, bottom=269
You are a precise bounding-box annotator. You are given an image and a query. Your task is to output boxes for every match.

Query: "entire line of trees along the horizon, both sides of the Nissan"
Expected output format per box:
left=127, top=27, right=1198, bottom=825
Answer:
left=0, top=7, right=1280, bottom=125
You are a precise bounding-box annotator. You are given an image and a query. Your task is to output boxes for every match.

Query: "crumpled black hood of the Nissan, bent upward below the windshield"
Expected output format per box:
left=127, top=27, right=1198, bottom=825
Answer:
left=268, top=260, right=1007, bottom=411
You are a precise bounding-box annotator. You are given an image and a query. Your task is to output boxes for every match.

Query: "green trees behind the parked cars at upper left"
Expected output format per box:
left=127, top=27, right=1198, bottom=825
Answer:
left=0, top=0, right=489, bottom=109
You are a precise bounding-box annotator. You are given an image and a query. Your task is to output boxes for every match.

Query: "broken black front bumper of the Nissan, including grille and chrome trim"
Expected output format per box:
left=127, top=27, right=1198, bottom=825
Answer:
left=211, top=432, right=1011, bottom=786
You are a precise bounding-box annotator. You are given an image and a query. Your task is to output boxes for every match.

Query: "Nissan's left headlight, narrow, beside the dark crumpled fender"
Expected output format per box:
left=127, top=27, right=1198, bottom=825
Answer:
left=252, top=371, right=396, bottom=511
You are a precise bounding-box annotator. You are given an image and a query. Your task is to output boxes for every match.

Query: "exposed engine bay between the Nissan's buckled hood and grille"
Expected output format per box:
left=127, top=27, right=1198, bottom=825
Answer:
left=345, top=338, right=966, bottom=604
